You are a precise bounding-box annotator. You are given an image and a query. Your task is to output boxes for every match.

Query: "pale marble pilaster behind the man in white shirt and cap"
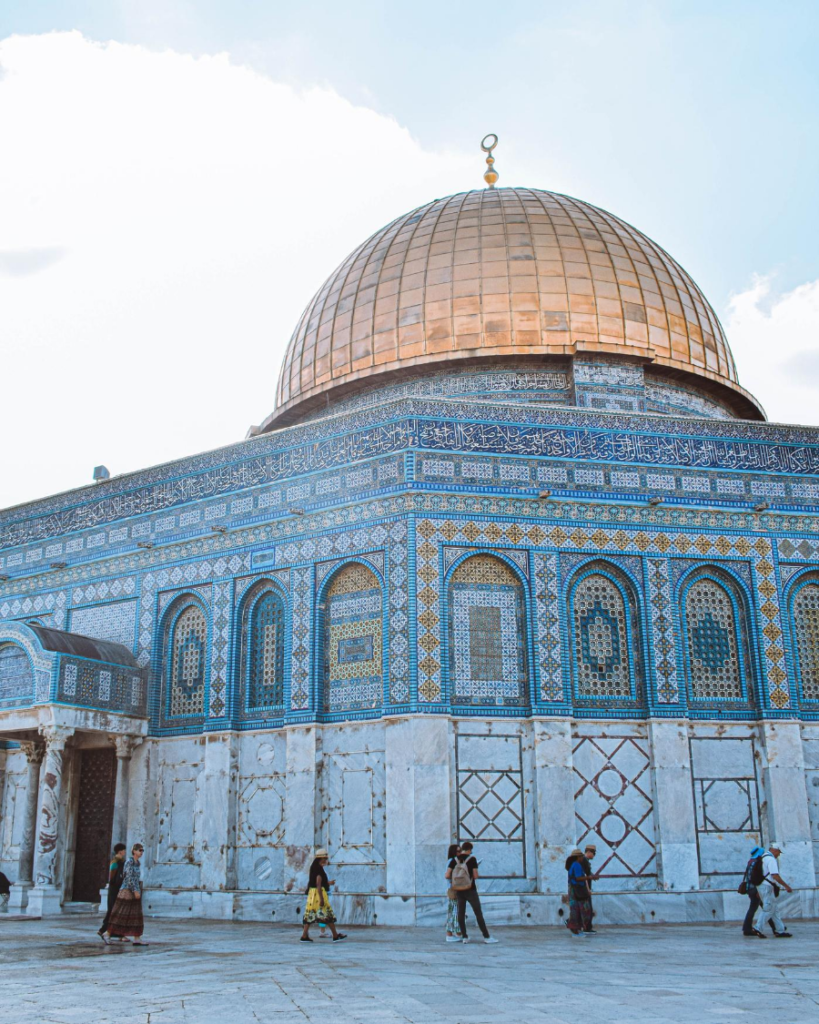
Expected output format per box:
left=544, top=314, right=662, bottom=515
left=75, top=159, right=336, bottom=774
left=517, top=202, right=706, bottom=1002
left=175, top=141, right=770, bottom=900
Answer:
left=759, top=721, right=816, bottom=892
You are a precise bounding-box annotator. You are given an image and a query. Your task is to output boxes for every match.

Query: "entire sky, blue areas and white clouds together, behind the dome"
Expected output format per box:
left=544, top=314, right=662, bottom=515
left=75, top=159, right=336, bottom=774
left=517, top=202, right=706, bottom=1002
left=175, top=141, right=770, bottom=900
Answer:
left=0, top=0, right=819, bottom=507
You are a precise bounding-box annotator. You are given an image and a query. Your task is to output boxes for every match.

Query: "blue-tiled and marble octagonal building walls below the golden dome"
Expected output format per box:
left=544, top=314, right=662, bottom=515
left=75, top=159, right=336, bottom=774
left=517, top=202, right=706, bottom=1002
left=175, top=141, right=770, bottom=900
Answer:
left=0, top=182, right=819, bottom=926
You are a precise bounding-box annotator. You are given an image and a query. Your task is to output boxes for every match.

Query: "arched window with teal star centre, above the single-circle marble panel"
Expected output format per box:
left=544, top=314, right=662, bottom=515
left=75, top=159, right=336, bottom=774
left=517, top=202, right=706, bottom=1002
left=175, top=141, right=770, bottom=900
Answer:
left=683, top=577, right=745, bottom=700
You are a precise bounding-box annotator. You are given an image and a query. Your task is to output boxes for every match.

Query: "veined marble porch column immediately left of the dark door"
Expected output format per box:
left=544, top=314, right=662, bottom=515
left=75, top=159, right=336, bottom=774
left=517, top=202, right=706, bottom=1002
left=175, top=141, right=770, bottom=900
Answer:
left=28, top=725, right=74, bottom=916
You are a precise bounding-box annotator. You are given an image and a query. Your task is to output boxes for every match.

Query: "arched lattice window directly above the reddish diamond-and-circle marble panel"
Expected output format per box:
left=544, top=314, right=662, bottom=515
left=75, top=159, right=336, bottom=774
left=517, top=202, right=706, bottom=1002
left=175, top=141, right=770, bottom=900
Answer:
left=570, top=566, right=642, bottom=700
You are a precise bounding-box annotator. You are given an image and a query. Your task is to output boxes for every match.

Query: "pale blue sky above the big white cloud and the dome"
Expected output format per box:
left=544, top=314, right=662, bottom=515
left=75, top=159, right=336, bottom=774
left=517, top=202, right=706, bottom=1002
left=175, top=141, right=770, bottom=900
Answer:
left=6, top=0, right=819, bottom=303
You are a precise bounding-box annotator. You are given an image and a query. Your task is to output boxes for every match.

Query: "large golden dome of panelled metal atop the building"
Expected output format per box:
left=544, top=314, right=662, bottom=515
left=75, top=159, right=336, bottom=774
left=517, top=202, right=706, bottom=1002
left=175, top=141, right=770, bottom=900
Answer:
left=262, top=188, right=763, bottom=429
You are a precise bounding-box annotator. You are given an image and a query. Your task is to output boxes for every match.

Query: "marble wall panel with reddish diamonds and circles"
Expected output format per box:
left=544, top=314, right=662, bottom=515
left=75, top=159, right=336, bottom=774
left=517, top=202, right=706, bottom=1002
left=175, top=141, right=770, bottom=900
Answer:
left=572, top=735, right=657, bottom=886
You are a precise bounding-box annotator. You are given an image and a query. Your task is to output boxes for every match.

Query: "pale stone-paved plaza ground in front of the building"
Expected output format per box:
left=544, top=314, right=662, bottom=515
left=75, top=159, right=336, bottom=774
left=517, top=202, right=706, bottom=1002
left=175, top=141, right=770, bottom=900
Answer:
left=0, top=915, right=819, bottom=1024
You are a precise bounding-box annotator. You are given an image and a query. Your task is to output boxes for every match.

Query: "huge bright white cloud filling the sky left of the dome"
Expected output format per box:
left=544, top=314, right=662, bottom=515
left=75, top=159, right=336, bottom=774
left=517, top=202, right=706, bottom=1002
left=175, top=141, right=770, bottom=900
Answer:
left=0, top=33, right=472, bottom=507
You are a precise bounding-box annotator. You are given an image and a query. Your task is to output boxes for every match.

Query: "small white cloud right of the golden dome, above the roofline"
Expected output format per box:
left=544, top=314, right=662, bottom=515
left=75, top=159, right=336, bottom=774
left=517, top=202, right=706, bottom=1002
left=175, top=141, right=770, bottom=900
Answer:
left=725, top=276, right=819, bottom=426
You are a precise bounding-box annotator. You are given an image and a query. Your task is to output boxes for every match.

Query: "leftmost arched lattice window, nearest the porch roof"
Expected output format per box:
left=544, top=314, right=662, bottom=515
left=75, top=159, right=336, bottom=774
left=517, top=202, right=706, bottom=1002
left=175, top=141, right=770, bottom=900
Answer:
left=166, top=598, right=208, bottom=718
